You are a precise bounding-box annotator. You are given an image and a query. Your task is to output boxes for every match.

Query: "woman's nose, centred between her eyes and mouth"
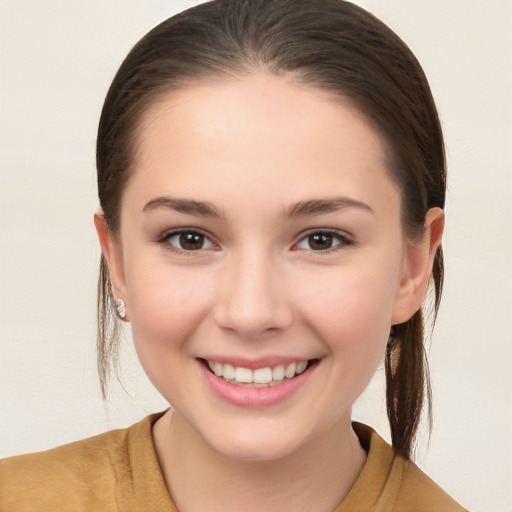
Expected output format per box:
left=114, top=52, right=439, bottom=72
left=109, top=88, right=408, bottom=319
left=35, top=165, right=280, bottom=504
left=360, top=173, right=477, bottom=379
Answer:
left=215, top=250, right=293, bottom=339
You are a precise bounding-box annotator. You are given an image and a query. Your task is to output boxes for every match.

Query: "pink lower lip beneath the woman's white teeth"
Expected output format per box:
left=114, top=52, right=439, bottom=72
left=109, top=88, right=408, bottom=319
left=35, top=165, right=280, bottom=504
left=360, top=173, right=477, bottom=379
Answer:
left=198, top=360, right=317, bottom=407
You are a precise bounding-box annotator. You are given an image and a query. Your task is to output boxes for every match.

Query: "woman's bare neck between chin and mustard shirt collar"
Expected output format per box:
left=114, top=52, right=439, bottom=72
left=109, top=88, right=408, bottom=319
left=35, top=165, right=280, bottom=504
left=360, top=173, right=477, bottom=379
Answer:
left=153, top=411, right=366, bottom=512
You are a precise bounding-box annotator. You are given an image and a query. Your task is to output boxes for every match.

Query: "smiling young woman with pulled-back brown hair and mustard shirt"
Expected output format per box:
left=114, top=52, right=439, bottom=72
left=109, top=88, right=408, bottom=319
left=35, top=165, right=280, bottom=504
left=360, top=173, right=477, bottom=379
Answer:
left=0, top=0, right=472, bottom=512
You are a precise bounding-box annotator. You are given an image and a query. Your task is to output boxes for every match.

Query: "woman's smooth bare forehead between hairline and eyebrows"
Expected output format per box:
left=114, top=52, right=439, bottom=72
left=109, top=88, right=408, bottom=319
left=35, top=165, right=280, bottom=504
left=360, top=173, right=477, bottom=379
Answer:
left=126, top=73, right=398, bottom=214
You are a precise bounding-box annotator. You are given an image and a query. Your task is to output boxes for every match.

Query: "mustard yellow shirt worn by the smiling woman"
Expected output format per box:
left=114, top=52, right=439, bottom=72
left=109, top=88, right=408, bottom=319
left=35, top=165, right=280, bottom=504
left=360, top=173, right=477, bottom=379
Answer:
left=0, top=413, right=464, bottom=512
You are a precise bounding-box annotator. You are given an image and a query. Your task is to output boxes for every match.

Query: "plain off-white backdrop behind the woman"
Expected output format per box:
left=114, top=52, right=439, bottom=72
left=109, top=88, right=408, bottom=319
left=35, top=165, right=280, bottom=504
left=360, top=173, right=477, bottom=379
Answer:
left=0, top=0, right=512, bottom=512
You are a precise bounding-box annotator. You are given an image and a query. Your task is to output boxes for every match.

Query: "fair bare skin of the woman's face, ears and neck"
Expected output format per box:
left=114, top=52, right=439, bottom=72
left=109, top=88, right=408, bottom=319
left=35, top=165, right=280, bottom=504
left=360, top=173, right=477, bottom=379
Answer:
left=95, top=71, right=443, bottom=512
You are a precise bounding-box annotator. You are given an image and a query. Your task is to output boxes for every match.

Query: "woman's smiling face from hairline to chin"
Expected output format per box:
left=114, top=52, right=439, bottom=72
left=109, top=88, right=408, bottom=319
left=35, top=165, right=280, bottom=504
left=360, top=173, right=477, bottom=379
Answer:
left=102, top=73, right=430, bottom=460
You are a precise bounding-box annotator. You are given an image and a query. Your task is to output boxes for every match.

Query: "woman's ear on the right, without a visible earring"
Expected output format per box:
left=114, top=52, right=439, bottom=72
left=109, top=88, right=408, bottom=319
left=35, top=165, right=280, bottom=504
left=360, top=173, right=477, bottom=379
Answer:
left=391, top=208, right=444, bottom=325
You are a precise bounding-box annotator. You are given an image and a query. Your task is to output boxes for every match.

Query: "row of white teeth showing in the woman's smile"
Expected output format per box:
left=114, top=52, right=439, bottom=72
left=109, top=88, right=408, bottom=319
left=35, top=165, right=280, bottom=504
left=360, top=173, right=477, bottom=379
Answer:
left=201, top=359, right=318, bottom=388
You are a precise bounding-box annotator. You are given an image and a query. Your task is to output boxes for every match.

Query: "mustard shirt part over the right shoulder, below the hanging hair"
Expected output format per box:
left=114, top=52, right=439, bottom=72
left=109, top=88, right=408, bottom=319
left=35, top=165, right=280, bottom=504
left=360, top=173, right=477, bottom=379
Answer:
left=341, top=423, right=465, bottom=512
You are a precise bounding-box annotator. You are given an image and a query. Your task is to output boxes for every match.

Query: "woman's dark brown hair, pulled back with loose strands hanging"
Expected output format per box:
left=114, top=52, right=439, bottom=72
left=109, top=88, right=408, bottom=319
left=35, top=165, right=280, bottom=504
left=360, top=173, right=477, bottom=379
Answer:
left=97, top=0, right=446, bottom=458
